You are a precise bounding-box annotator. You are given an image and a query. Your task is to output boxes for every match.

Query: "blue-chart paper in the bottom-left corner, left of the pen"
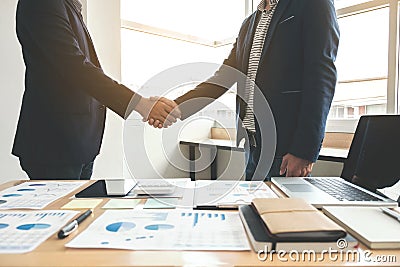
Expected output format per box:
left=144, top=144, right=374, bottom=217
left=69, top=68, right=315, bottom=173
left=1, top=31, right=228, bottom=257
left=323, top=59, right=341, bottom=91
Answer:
left=0, top=210, right=78, bottom=254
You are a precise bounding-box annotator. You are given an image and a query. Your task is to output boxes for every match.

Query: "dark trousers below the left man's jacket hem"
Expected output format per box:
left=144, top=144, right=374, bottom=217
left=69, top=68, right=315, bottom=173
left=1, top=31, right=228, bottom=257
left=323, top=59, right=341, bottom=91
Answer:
left=20, top=159, right=93, bottom=180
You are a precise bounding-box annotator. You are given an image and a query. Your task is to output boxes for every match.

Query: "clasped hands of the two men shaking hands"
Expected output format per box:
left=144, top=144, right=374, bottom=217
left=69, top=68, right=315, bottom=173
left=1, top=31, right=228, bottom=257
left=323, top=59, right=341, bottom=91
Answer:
left=135, top=97, right=181, bottom=128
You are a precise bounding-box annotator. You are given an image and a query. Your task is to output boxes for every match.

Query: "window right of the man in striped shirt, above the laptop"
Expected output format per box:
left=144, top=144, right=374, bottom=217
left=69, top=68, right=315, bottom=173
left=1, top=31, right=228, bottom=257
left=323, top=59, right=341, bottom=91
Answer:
left=327, top=0, right=398, bottom=132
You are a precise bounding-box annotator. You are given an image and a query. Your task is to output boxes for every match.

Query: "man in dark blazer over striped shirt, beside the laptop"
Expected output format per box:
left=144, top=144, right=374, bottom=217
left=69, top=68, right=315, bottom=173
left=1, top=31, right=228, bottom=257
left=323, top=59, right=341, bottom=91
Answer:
left=149, top=0, right=339, bottom=180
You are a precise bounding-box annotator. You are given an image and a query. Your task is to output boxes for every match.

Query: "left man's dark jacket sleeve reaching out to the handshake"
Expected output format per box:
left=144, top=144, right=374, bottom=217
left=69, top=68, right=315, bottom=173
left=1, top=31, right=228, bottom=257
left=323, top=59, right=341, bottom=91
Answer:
left=17, top=0, right=140, bottom=118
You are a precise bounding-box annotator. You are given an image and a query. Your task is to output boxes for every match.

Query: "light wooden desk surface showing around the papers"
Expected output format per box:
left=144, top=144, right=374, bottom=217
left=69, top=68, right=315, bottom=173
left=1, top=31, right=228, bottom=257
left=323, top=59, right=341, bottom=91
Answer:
left=0, top=182, right=400, bottom=267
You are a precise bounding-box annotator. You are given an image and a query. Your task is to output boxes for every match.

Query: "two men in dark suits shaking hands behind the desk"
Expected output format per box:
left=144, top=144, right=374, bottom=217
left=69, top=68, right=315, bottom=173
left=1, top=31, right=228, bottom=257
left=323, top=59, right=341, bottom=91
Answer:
left=12, top=0, right=339, bottom=179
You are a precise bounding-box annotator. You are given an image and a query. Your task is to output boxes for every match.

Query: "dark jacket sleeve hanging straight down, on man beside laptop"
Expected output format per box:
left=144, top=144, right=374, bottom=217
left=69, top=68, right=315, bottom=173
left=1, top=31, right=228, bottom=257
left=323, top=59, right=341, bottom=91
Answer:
left=289, top=0, right=339, bottom=162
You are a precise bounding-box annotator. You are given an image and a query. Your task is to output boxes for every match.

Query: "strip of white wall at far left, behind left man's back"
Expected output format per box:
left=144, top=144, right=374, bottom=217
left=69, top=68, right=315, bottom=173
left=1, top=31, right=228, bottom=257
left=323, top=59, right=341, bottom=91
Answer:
left=0, top=0, right=27, bottom=183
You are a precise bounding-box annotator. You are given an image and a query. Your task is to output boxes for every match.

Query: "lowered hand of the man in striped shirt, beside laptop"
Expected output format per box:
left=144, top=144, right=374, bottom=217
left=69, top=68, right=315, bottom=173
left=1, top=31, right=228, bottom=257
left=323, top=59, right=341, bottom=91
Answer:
left=280, top=154, right=314, bottom=177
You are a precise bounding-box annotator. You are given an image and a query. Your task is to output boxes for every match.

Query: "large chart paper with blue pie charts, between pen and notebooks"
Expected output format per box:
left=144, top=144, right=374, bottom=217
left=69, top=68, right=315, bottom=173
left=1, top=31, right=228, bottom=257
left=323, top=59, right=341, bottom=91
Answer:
left=66, top=209, right=250, bottom=251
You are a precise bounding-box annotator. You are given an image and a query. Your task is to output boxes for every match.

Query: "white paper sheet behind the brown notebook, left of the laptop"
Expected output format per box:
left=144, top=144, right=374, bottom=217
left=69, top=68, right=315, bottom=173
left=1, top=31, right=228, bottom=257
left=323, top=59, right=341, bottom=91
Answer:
left=194, top=181, right=278, bottom=206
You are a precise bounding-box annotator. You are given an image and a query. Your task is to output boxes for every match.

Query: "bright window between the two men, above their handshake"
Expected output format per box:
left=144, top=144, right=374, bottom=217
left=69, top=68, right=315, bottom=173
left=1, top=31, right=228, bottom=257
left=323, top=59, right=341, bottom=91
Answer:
left=121, top=0, right=252, bottom=128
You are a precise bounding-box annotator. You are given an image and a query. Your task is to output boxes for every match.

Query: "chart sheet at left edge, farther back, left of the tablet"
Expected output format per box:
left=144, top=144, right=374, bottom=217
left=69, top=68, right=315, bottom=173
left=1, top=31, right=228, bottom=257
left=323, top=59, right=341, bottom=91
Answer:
left=0, top=181, right=87, bottom=210
